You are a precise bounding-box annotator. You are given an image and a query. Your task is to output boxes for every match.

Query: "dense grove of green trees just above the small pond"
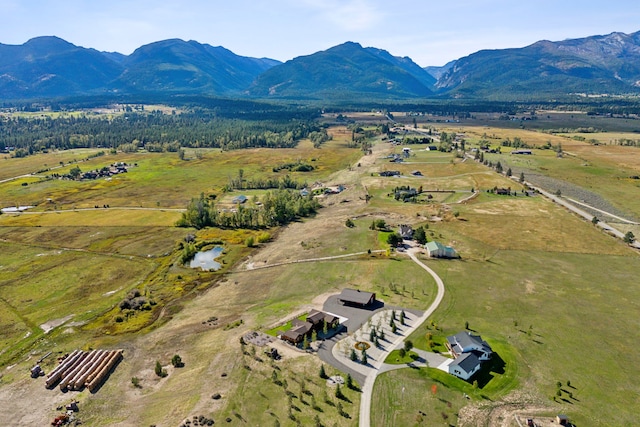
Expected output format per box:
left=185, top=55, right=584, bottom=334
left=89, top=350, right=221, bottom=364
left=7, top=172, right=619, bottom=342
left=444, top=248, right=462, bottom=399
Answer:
left=176, top=189, right=320, bottom=229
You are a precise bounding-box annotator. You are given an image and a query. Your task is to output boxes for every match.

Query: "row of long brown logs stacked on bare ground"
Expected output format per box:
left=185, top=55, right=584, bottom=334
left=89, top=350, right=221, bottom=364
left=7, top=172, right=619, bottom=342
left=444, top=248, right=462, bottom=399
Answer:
left=45, top=350, right=123, bottom=391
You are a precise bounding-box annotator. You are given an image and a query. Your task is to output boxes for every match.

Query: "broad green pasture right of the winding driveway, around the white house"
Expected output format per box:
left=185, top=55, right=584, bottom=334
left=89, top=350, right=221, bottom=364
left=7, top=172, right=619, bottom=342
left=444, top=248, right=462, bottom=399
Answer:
left=402, top=248, right=640, bottom=425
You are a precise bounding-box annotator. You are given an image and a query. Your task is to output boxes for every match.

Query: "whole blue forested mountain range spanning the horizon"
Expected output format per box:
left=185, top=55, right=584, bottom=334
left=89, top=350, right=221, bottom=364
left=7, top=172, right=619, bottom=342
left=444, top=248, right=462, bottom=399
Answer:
left=0, top=32, right=640, bottom=100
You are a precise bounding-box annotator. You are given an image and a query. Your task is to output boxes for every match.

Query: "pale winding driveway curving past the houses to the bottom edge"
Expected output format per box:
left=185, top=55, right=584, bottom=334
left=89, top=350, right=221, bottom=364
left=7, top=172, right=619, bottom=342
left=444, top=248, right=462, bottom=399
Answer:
left=359, top=248, right=444, bottom=427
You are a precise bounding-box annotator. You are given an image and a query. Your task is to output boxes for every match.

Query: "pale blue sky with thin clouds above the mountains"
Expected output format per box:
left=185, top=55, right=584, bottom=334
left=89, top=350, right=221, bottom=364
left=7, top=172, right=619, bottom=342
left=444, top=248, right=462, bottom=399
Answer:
left=0, top=0, right=640, bottom=66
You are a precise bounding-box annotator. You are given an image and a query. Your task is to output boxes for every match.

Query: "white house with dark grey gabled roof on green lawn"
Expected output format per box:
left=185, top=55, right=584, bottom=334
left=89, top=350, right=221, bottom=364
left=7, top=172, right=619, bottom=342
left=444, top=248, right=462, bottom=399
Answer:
left=447, top=332, right=493, bottom=380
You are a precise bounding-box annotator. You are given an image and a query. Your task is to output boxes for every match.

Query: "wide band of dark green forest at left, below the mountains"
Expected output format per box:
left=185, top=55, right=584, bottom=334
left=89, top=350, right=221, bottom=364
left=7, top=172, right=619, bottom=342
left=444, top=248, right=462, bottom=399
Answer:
left=0, top=109, right=322, bottom=157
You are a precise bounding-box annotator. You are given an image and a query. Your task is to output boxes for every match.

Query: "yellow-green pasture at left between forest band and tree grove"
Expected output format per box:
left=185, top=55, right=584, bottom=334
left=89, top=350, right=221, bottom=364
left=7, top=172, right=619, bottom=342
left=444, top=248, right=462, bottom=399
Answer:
left=0, top=138, right=360, bottom=210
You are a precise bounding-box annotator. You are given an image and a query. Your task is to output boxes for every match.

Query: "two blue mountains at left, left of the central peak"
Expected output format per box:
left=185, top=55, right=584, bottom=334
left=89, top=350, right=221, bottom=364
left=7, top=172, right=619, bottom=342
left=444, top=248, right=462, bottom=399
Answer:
left=0, top=37, right=279, bottom=99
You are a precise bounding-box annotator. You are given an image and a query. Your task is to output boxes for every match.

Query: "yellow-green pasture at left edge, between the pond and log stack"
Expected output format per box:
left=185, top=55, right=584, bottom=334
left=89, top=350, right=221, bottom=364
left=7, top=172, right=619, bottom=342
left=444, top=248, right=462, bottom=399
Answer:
left=0, top=242, right=154, bottom=362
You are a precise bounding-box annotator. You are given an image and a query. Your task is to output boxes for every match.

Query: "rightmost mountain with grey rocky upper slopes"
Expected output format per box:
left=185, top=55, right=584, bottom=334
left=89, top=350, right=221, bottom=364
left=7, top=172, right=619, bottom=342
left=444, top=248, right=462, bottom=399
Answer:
left=436, top=32, right=640, bottom=98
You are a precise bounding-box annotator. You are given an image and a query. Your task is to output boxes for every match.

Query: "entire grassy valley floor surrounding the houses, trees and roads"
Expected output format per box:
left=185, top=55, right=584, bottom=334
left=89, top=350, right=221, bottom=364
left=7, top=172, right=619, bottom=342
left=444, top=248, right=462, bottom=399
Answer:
left=0, top=113, right=640, bottom=426
